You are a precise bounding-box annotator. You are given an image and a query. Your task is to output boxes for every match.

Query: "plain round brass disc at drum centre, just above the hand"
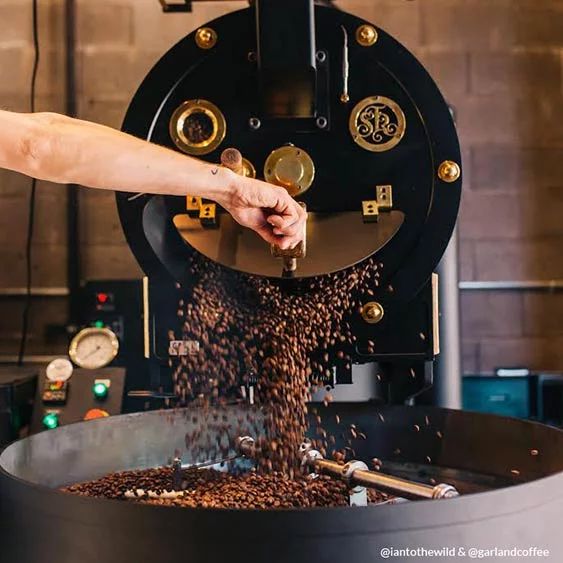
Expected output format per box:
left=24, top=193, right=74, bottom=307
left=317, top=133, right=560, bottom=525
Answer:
left=264, top=146, right=315, bottom=196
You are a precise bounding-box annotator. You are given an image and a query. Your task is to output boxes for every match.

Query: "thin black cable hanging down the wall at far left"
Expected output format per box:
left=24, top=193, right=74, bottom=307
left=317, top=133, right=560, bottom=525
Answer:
left=18, top=0, right=40, bottom=366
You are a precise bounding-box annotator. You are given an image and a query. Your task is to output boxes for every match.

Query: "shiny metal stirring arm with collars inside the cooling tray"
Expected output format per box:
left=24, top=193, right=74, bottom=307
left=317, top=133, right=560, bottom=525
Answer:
left=237, top=436, right=459, bottom=500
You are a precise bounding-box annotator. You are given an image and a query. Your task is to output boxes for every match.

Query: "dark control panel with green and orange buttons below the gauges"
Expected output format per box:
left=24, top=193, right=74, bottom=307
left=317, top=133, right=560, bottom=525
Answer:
left=31, top=367, right=125, bottom=433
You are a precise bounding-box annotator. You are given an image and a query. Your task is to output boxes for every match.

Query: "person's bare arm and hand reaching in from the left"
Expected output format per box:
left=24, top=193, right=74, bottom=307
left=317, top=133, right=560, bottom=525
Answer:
left=0, top=111, right=306, bottom=248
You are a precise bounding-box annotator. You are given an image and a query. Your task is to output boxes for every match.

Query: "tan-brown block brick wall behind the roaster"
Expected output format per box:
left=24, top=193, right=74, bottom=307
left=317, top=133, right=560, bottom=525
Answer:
left=0, top=0, right=563, bottom=372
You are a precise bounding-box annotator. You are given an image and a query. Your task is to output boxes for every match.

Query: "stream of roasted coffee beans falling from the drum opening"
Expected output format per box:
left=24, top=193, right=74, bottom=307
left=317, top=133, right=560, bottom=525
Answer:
left=174, top=254, right=381, bottom=476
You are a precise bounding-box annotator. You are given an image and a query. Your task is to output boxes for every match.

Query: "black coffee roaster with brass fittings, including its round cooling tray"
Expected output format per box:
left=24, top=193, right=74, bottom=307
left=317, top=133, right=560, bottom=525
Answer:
left=0, top=0, right=563, bottom=563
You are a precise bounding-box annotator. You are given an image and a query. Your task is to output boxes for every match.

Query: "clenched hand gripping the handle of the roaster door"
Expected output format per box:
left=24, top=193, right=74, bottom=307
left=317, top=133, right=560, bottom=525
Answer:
left=218, top=175, right=307, bottom=250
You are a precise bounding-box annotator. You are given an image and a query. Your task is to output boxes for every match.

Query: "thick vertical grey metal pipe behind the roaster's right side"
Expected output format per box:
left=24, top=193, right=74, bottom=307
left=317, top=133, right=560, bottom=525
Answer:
left=434, top=228, right=462, bottom=409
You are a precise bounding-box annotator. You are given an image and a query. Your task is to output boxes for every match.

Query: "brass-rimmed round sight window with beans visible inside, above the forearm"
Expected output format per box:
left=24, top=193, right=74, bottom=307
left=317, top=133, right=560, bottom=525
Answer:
left=170, top=100, right=227, bottom=156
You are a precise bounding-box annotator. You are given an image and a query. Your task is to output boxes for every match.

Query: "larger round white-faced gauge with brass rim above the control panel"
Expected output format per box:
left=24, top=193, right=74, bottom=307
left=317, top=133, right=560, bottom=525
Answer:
left=68, top=328, right=119, bottom=369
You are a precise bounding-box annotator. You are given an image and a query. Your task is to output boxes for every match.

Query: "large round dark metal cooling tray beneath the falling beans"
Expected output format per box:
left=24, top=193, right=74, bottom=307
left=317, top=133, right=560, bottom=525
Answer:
left=0, top=405, right=563, bottom=563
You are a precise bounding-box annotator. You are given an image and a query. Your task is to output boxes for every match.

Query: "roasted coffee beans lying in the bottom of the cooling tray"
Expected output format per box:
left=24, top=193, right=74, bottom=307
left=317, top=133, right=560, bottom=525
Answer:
left=64, top=468, right=387, bottom=509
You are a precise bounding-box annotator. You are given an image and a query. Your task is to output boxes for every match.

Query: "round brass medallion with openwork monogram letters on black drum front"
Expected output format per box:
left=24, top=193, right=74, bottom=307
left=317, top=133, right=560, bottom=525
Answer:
left=349, top=96, right=407, bottom=152
